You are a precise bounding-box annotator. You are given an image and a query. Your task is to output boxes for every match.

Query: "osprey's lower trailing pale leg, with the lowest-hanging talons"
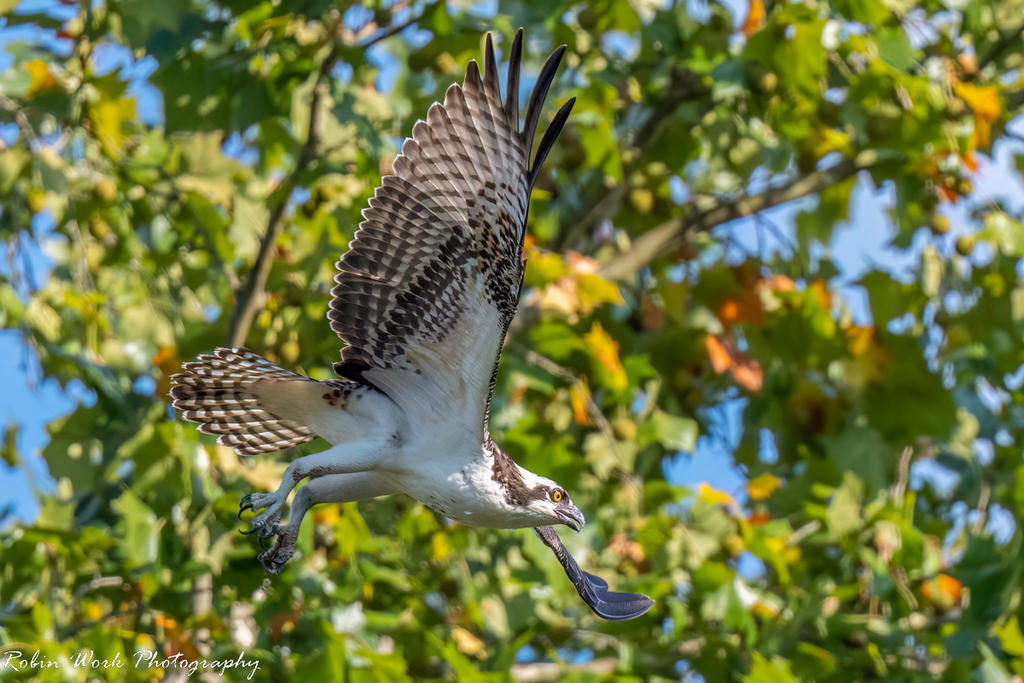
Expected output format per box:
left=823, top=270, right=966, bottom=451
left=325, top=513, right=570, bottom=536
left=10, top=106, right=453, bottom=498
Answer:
left=257, top=472, right=397, bottom=573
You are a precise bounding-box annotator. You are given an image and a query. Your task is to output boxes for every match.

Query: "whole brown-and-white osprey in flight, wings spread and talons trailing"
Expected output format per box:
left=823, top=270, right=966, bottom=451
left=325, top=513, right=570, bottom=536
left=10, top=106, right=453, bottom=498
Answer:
left=171, top=30, right=653, bottom=620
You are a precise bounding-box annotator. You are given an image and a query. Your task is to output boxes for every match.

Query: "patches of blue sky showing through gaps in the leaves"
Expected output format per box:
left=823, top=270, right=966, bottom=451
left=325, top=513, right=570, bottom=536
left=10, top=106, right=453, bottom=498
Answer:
left=0, top=0, right=1024, bottom=573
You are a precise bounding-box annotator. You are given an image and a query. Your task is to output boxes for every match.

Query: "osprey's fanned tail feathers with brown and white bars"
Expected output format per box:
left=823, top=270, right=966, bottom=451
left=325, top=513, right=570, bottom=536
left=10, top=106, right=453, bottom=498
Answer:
left=171, top=347, right=318, bottom=456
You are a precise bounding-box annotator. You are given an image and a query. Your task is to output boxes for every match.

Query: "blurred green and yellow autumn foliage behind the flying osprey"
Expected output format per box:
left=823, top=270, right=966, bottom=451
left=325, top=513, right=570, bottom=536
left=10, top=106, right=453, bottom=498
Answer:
left=0, top=0, right=1024, bottom=681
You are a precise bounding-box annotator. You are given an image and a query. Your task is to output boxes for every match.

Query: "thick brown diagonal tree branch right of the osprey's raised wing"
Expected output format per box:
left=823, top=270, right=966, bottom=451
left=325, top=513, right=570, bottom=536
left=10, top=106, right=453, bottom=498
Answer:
left=600, top=152, right=890, bottom=282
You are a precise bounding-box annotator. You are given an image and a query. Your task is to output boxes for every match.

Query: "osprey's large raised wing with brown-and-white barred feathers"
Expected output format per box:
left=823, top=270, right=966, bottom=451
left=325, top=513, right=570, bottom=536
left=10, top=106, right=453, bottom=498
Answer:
left=328, top=30, right=574, bottom=428
